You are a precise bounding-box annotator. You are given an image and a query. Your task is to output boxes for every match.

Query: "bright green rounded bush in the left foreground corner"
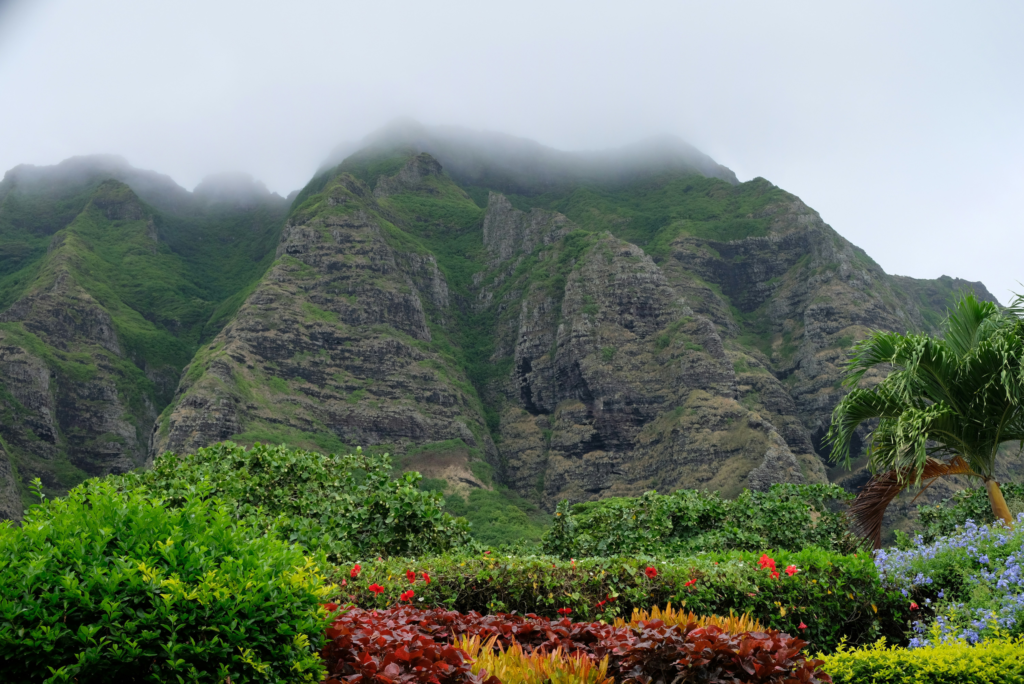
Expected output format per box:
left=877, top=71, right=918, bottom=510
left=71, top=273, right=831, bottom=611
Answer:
left=0, top=480, right=331, bottom=683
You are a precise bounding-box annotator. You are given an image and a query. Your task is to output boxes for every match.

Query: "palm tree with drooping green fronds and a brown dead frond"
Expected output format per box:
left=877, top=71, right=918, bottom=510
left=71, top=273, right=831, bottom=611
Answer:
left=826, top=295, right=1024, bottom=548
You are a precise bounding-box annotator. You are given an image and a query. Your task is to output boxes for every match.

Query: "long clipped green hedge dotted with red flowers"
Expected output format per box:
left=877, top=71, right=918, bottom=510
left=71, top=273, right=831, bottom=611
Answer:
left=327, top=549, right=911, bottom=650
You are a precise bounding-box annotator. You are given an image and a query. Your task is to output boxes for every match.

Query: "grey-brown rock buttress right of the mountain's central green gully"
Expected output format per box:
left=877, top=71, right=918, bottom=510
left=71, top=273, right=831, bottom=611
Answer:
left=479, top=195, right=824, bottom=503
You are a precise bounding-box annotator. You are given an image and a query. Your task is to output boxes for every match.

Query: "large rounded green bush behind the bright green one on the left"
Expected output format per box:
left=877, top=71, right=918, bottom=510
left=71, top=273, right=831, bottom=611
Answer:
left=116, top=441, right=471, bottom=562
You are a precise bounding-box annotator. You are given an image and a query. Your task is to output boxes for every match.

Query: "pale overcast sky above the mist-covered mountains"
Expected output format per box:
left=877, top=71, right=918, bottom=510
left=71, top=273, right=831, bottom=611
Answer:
left=0, top=0, right=1024, bottom=302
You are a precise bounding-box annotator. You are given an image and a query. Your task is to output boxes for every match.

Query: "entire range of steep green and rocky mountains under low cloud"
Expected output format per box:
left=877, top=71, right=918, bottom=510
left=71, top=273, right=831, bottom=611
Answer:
left=0, top=127, right=1014, bottom=532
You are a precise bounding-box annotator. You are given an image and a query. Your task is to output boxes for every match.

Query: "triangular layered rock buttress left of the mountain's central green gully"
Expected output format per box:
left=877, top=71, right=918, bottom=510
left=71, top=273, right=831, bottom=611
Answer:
left=153, top=171, right=494, bottom=477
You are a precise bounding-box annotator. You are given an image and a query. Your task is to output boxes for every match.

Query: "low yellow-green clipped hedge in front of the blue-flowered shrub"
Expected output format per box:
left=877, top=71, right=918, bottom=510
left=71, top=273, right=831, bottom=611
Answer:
left=818, top=639, right=1024, bottom=684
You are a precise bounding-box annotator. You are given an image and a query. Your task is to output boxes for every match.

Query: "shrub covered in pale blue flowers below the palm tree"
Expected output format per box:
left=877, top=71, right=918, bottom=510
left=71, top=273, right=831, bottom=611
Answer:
left=876, top=514, right=1024, bottom=647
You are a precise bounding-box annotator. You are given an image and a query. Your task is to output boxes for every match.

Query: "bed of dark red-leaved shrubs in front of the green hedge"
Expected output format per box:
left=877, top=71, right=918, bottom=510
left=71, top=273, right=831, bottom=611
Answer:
left=324, top=606, right=830, bottom=684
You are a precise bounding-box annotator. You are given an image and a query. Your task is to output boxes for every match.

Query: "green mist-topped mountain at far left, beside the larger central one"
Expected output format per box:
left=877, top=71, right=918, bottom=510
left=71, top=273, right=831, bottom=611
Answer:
left=0, top=157, right=288, bottom=517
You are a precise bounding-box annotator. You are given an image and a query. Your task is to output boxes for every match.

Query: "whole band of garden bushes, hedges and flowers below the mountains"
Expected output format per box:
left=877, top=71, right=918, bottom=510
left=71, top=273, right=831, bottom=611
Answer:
left=0, top=442, right=1024, bottom=684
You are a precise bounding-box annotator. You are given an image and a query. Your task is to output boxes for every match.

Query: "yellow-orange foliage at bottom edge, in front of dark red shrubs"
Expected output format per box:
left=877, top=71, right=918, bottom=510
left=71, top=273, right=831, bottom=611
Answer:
left=456, top=636, right=613, bottom=684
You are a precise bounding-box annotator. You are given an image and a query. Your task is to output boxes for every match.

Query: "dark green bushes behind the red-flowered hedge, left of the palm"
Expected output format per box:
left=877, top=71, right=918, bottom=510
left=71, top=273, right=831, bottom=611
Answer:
left=543, top=484, right=866, bottom=558
